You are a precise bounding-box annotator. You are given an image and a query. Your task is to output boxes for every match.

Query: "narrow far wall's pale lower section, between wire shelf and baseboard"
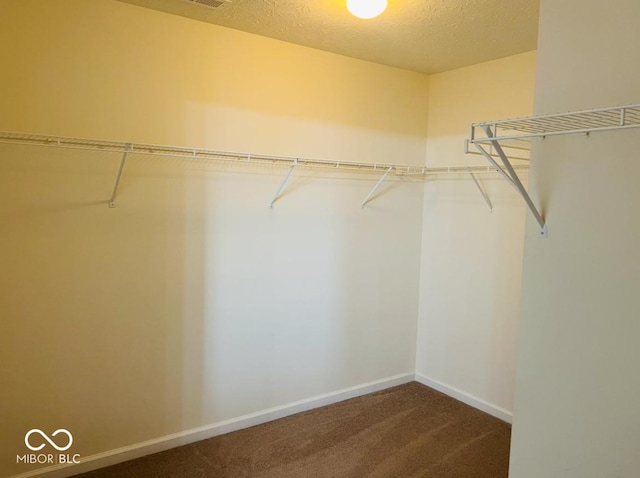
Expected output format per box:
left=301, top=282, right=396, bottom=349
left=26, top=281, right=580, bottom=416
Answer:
left=416, top=177, right=526, bottom=410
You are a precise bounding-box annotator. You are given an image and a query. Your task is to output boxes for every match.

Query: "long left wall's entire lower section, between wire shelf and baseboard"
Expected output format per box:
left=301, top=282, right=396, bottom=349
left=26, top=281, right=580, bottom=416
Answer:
left=0, top=145, right=422, bottom=473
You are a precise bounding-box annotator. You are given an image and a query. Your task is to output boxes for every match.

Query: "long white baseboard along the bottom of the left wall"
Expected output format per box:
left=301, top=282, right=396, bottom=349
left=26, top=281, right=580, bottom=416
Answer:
left=13, top=373, right=418, bottom=478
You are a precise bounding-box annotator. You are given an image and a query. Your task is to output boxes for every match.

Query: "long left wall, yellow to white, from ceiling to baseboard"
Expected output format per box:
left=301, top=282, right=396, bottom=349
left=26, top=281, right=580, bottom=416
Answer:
left=0, top=0, right=428, bottom=476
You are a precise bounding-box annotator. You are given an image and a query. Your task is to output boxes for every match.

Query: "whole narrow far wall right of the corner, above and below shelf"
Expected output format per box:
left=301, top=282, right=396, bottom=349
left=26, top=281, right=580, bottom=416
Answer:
left=416, top=52, right=536, bottom=419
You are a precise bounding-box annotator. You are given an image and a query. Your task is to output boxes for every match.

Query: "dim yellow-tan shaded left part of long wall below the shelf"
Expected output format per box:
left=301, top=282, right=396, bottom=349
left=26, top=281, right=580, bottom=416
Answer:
left=0, top=146, right=206, bottom=476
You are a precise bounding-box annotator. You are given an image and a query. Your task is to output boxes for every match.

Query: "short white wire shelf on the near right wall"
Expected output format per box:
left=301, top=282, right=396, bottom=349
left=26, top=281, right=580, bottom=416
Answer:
left=468, top=104, right=640, bottom=143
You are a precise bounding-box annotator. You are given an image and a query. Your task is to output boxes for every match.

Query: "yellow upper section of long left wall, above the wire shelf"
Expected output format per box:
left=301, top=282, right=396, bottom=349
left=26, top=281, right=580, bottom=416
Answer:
left=0, top=0, right=427, bottom=164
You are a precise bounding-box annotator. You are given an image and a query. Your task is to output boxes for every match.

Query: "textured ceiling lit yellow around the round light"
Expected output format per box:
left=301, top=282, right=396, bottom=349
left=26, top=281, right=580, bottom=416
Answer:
left=120, top=0, right=539, bottom=73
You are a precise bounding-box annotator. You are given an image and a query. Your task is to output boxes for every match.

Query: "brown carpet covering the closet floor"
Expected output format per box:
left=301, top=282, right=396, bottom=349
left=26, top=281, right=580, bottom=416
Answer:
left=79, top=382, right=511, bottom=478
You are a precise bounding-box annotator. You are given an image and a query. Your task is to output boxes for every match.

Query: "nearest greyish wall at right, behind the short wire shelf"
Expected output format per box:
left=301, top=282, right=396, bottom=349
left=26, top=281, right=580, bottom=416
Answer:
left=510, top=0, right=640, bottom=478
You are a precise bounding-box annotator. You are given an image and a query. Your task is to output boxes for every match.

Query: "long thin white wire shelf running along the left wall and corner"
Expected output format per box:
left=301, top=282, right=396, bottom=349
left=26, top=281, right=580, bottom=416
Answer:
left=0, top=132, right=528, bottom=177
